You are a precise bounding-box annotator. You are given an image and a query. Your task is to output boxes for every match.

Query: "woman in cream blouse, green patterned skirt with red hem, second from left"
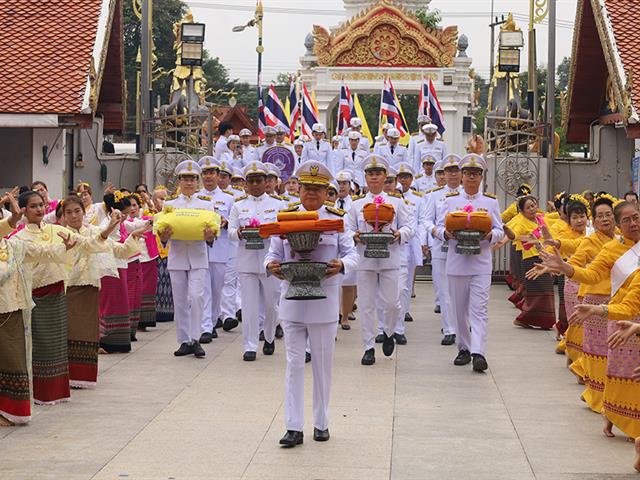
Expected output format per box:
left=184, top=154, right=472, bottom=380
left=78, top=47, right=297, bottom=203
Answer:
left=12, top=191, right=98, bottom=405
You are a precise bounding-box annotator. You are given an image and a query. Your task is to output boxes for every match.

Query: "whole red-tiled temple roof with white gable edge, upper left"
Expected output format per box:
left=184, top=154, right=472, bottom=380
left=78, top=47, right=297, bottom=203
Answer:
left=0, top=0, right=124, bottom=130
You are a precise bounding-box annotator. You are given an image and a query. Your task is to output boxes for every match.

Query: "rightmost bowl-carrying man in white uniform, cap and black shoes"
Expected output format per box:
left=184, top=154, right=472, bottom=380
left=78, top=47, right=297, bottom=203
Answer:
left=436, top=153, right=504, bottom=372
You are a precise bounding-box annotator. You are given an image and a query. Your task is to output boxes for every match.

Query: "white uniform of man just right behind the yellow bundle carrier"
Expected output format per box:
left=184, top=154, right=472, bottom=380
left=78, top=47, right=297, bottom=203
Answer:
left=199, top=182, right=235, bottom=333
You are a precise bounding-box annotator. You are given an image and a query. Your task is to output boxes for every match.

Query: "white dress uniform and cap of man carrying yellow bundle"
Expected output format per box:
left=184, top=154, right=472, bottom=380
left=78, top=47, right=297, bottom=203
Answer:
left=165, top=164, right=211, bottom=344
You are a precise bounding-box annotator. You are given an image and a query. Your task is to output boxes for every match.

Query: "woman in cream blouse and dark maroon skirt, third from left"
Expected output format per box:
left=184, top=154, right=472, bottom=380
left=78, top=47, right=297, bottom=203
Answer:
left=63, top=196, right=142, bottom=388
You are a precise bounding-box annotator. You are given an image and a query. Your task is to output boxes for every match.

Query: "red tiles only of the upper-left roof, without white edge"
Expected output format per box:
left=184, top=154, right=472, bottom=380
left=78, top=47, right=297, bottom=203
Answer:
left=0, top=0, right=102, bottom=114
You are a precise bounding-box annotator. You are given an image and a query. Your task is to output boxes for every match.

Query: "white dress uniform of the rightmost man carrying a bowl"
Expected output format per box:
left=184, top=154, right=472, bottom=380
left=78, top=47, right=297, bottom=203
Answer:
left=436, top=156, right=504, bottom=356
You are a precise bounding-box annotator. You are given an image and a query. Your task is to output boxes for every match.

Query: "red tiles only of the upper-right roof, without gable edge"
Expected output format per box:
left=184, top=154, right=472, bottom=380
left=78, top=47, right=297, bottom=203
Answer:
left=605, top=0, right=640, bottom=113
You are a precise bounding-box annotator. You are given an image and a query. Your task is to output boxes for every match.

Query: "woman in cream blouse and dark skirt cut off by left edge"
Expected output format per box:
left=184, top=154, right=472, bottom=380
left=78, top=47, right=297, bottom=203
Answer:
left=0, top=201, right=71, bottom=426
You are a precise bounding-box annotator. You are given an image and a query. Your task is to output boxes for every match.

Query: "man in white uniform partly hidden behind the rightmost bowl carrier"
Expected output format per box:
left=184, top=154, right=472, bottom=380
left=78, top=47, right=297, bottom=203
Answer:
left=425, top=153, right=462, bottom=345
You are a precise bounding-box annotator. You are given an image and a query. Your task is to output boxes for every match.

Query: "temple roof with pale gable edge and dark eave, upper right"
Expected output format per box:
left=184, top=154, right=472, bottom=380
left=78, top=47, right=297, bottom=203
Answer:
left=565, top=0, right=640, bottom=143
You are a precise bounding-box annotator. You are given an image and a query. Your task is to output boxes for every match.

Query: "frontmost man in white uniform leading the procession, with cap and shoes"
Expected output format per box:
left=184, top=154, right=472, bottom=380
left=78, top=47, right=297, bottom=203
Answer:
left=264, top=160, right=358, bottom=447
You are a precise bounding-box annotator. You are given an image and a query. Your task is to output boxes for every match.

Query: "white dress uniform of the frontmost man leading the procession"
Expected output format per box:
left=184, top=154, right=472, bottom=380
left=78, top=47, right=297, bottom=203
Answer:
left=264, top=201, right=358, bottom=431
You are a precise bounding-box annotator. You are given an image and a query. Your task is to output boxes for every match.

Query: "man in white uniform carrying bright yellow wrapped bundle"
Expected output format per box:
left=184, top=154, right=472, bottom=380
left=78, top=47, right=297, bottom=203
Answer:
left=159, top=160, right=215, bottom=358
